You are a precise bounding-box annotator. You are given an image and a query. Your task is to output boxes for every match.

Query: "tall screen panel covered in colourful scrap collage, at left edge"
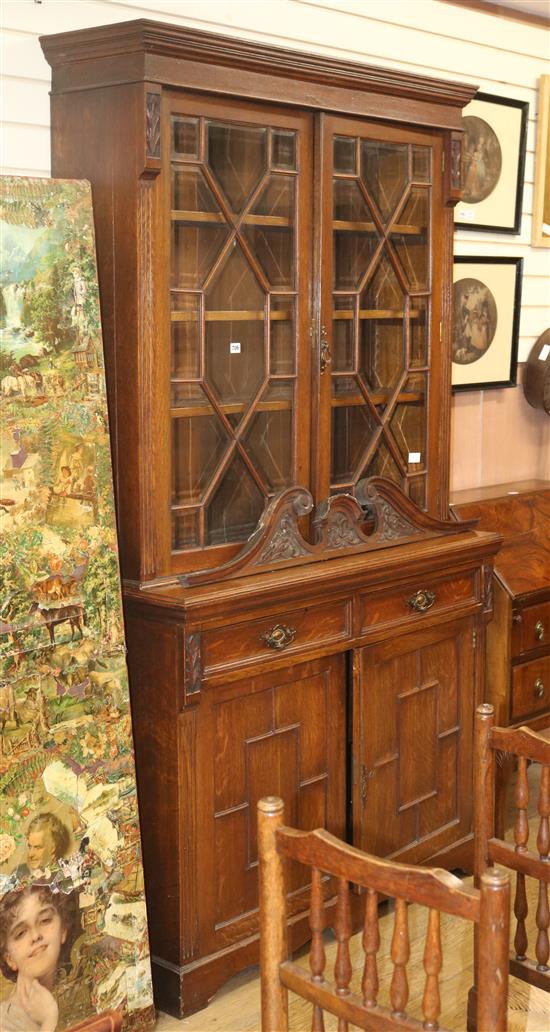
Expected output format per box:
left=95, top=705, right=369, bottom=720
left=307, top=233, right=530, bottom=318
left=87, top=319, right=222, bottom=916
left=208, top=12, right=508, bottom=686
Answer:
left=0, top=178, right=154, bottom=1032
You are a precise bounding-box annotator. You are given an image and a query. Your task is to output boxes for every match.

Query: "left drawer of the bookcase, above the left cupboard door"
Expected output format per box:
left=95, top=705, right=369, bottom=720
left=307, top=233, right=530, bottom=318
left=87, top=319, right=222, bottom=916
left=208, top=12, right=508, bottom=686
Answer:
left=202, top=600, right=351, bottom=674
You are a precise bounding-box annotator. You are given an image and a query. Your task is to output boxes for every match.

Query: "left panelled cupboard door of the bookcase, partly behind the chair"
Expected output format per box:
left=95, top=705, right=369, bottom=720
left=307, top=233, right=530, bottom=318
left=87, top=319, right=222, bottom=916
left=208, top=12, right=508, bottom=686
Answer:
left=191, top=655, right=346, bottom=954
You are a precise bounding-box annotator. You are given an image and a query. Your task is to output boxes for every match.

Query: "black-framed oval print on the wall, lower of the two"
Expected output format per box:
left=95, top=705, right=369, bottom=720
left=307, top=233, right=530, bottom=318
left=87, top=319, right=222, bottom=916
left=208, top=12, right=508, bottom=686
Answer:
left=452, top=257, right=523, bottom=390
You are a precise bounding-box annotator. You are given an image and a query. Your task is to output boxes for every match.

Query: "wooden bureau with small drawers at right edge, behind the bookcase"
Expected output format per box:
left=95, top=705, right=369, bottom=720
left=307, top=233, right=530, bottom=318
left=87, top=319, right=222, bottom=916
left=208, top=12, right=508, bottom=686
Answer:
left=451, top=481, right=550, bottom=729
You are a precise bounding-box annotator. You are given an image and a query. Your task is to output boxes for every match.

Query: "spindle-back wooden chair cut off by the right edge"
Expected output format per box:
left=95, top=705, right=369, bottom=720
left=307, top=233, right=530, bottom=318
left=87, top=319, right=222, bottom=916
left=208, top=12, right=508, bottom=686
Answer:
left=474, top=703, right=550, bottom=992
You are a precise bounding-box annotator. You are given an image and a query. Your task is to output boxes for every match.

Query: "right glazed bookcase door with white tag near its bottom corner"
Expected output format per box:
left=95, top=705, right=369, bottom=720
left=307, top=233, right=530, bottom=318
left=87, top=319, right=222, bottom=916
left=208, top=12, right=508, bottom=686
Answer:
left=317, top=117, right=448, bottom=514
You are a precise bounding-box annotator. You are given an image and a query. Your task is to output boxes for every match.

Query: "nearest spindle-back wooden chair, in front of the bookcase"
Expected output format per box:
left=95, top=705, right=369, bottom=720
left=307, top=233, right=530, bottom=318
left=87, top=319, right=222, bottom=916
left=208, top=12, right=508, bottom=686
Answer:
left=258, top=797, right=510, bottom=1032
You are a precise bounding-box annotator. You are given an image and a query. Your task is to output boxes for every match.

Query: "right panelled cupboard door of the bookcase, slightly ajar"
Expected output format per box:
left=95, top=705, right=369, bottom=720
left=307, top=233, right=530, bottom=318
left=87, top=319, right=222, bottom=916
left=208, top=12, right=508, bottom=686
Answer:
left=353, top=619, right=475, bottom=863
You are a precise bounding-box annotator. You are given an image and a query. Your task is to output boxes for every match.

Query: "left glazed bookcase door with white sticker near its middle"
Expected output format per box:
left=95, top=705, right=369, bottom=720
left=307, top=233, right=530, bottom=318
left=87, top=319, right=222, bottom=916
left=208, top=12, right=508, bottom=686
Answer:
left=164, top=94, right=312, bottom=571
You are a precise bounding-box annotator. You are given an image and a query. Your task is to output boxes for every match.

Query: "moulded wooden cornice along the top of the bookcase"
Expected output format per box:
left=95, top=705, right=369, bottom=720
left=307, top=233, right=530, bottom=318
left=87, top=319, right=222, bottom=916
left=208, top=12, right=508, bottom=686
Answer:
left=40, top=19, right=477, bottom=107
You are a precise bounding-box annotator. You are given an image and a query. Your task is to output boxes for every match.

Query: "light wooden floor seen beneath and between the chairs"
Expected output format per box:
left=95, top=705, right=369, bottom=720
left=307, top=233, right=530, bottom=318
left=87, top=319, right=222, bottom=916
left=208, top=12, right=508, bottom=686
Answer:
left=156, top=766, right=550, bottom=1032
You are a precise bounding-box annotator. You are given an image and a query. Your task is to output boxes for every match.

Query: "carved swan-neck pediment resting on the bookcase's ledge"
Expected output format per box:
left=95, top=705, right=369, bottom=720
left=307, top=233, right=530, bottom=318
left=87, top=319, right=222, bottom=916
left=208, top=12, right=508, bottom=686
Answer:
left=180, top=477, right=476, bottom=585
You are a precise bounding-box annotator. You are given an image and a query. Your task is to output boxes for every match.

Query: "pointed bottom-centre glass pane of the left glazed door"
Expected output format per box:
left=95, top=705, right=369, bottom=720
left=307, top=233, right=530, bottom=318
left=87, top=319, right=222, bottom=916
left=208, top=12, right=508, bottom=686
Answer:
left=206, top=454, right=264, bottom=545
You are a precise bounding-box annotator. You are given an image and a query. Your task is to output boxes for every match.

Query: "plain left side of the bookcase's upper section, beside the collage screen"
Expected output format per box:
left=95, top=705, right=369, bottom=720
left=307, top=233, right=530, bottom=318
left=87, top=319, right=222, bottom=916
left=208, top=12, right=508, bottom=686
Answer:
left=52, top=86, right=163, bottom=579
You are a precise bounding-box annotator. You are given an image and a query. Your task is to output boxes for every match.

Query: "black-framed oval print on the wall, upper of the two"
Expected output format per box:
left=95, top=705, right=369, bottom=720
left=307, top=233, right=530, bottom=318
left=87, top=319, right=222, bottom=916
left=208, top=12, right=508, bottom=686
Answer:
left=455, top=93, right=529, bottom=233
